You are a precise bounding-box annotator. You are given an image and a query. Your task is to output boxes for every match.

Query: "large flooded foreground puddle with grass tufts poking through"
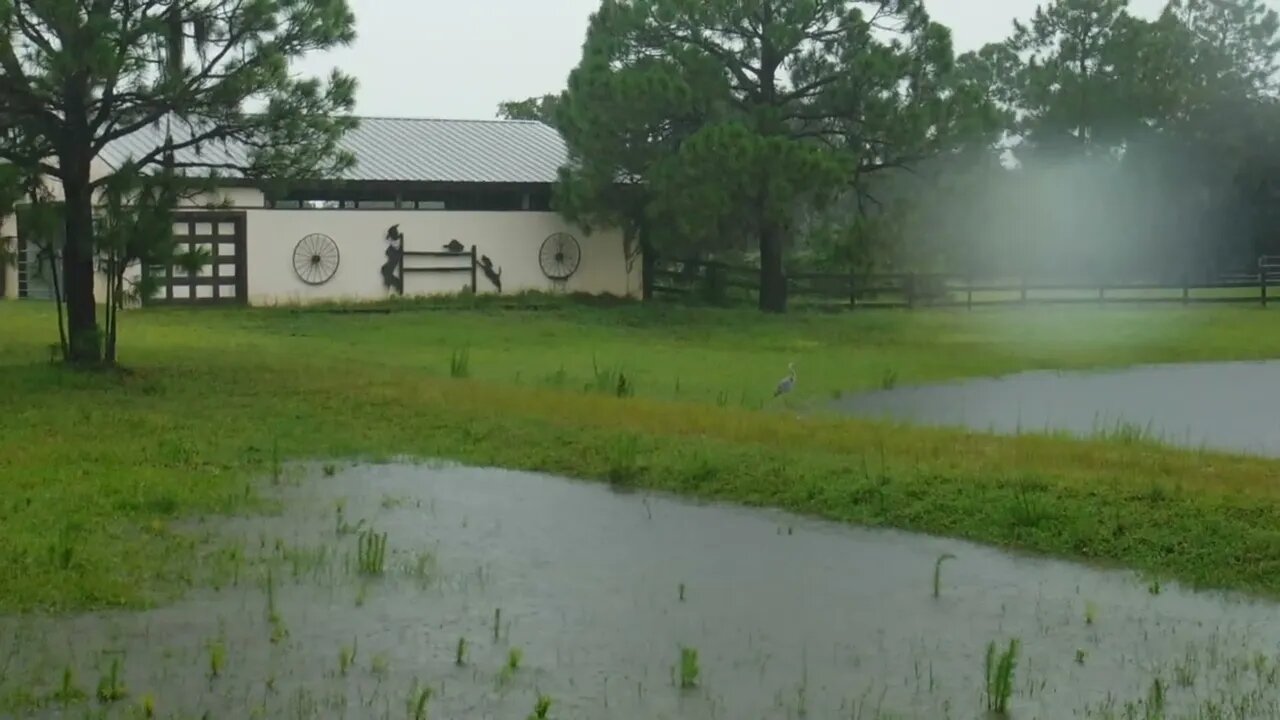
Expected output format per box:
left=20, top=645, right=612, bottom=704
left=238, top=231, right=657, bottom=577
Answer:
left=0, top=464, right=1280, bottom=720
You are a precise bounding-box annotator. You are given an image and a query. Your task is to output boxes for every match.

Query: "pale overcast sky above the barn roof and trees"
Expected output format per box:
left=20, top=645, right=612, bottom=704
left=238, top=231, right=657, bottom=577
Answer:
left=298, top=0, right=1177, bottom=119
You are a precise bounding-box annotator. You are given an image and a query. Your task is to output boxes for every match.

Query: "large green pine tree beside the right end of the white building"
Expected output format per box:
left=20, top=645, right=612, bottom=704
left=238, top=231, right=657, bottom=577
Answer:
left=558, top=0, right=998, bottom=304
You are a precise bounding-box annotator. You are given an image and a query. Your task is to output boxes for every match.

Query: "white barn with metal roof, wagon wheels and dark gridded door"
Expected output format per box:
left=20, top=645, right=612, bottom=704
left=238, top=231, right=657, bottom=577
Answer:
left=0, top=118, right=640, bottom=305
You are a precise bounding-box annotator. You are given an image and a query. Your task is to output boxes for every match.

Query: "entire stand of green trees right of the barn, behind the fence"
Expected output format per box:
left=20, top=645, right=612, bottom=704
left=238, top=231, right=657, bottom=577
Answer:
left=504, top=0, right=1280, bottom=304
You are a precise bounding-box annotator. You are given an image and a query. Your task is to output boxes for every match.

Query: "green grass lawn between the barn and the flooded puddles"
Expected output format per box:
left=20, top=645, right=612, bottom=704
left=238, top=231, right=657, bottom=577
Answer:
left=0, top=297, right=1280, bottom=610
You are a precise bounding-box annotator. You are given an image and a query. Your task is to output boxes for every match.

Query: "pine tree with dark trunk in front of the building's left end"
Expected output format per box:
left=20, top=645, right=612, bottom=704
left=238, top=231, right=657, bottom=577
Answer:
left=0, top=0, right=355, bottom=364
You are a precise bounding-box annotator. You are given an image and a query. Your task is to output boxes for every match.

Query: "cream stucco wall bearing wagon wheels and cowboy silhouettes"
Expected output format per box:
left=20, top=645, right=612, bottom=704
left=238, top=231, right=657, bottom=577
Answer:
left=238, top=210, right=640, bottom=305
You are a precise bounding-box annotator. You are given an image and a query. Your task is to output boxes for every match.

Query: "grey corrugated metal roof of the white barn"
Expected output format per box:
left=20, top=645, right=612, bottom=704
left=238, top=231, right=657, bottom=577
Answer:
left=101, top=118, right=568, bottom=183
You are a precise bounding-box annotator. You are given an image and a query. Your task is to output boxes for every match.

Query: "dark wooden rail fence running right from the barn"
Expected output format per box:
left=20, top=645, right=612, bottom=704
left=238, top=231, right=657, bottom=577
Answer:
left=653, top=256, right=1280, bottom=309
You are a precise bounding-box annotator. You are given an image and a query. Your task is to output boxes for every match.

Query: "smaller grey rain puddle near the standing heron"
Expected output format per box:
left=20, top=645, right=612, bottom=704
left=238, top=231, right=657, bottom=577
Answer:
left=835, top=361, right=1280, bottom=455
